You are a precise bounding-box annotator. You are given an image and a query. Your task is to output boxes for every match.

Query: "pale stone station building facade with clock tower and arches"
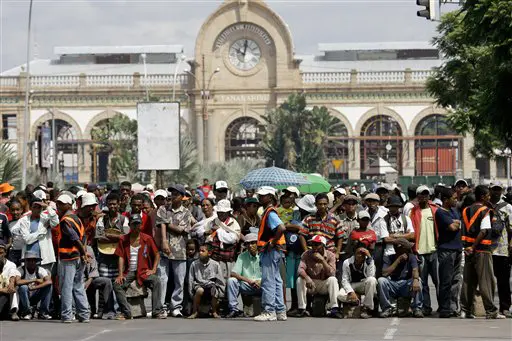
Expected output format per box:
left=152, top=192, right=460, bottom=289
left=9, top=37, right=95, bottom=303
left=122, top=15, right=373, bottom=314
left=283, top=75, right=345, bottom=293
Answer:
left=0, top=0, right=505, bottom=182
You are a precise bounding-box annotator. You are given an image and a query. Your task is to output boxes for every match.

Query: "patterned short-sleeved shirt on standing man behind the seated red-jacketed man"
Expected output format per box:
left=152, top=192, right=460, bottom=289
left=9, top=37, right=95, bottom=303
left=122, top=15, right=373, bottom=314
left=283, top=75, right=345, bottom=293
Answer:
left=156, top=206, right=194, bottom=260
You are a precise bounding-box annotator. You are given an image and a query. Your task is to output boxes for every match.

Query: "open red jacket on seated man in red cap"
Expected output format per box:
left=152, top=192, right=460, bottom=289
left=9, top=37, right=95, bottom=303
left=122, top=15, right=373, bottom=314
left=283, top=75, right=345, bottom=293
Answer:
left=115, top=233, right=158, bottom=285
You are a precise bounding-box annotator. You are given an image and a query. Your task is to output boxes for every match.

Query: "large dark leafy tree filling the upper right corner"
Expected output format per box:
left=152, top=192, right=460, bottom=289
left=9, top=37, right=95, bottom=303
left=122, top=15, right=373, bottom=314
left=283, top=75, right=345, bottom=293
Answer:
left=427, top=0, right=512, bottom=155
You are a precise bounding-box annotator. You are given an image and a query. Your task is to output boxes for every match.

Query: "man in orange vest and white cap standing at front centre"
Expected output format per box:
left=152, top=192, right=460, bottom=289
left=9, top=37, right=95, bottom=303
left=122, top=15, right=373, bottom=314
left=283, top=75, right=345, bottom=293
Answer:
left=254, top=186, right=287, bottom=322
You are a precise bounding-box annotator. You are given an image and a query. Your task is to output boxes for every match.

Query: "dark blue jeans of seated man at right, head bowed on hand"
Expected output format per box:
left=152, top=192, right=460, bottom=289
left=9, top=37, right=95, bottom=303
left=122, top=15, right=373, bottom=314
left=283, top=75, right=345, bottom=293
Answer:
left=379, top=277, right=423, bottom=311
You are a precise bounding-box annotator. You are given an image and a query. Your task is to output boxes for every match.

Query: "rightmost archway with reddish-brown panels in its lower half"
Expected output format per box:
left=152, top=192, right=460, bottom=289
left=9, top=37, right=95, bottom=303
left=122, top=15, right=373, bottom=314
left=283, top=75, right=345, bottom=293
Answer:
left=414, top=114, right=460, bottom=176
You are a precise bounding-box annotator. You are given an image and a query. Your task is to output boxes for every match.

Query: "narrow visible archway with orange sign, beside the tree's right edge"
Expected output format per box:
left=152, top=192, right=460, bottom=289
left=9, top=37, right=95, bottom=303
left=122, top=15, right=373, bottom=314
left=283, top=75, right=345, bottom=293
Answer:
left=325, top=118, right=348, bottom=180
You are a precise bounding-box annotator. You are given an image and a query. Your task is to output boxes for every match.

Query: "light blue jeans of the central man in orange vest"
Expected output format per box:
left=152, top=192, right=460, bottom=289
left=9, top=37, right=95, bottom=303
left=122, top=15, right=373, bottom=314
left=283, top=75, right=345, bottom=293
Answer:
left=260, top=250, right=286, bottom=313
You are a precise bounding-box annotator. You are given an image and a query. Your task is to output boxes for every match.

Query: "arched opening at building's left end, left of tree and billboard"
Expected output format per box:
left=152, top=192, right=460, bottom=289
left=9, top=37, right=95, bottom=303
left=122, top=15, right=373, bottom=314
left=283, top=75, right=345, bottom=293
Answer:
left=42, top=119, right=79, bottom=183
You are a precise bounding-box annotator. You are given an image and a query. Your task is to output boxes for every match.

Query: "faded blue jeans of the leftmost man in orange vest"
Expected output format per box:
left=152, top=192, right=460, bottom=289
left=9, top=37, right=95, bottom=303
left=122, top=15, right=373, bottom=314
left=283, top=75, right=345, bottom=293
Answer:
left=59, top=259, right=90, bottom=321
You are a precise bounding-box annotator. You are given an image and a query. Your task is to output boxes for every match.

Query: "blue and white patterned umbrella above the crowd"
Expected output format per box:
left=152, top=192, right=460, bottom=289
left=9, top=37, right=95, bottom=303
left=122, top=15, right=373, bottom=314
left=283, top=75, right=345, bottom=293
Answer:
left=240, top=167, right=311, bottom=189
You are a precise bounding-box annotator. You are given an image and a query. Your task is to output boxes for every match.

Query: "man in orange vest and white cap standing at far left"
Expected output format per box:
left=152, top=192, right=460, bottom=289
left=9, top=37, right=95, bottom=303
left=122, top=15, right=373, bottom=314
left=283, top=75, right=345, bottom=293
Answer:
left=57, top=194, right=90, bottom=323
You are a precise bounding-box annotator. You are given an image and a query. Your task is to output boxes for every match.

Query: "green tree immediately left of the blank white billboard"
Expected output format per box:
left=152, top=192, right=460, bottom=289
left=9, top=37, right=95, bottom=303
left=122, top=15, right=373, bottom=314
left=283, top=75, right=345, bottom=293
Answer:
left=91, top=114, right=138, bottom=181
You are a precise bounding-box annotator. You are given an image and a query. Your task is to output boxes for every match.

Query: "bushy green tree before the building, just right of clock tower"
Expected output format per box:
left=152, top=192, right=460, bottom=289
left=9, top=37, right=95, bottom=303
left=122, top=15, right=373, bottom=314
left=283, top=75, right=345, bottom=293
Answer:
left=263, top=94, right=339, bottom=173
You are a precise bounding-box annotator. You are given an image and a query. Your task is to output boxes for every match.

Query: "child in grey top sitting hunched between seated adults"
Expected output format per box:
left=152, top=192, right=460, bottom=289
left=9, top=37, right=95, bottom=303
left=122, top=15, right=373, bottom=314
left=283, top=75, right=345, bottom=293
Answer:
left=188, top=245, right=222, bottom=319
